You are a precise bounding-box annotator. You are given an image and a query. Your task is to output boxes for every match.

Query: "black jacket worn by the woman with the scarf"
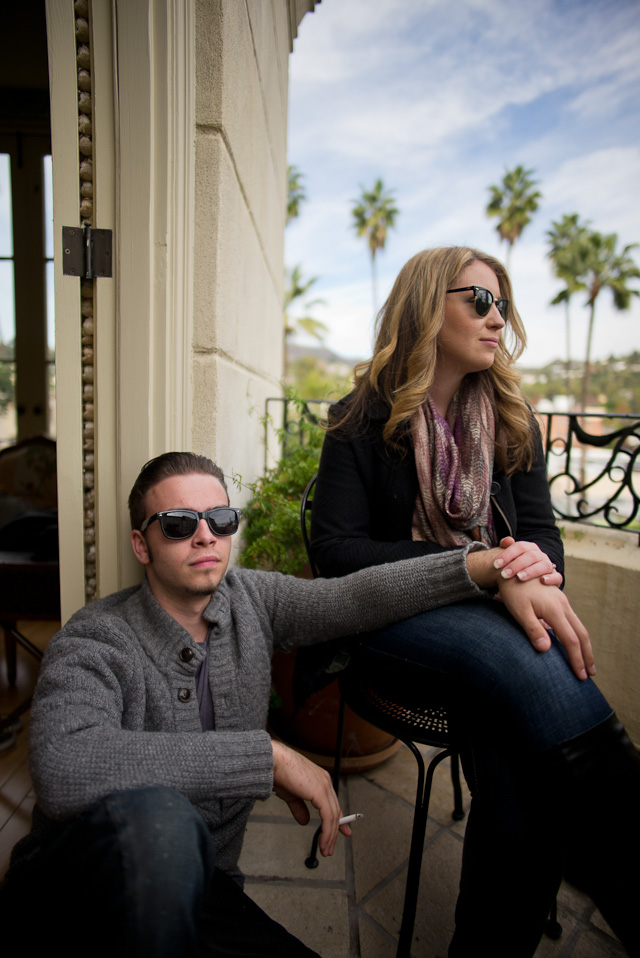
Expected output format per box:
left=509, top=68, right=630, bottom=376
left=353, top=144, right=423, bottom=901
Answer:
left=311, top=396, right=564, bottom=576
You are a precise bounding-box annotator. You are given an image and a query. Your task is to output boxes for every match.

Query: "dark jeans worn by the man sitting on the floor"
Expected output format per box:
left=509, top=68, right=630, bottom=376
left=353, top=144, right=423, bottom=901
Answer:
left=2, top=787, right=318, bottom=958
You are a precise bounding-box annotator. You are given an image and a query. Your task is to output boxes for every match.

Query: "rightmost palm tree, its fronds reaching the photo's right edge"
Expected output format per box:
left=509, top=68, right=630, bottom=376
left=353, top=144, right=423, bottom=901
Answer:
left=577, top=232, right=640, bottom=412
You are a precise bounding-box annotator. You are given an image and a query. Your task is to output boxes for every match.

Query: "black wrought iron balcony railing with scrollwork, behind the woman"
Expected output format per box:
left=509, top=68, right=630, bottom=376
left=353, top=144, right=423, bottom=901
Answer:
left=265, top=397, right=640, bottom=545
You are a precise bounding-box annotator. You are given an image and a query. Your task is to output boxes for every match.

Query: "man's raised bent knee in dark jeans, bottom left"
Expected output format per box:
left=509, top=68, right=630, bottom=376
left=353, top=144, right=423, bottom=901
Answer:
left=9, top=787, right=215, bottom=956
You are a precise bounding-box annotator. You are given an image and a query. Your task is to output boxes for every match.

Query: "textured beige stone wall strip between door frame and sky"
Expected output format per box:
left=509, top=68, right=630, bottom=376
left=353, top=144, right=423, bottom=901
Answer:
left=192, top=0, right=290, bottom=532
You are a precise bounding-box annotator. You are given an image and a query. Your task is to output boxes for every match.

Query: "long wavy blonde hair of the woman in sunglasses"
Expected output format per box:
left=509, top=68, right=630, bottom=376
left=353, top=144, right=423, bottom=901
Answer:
left=336, top=246, right=532, bottom=473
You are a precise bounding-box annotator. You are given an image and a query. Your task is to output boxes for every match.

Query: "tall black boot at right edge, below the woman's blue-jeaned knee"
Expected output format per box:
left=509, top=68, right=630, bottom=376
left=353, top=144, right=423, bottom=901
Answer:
left=546, top=715, right=640, bottom=958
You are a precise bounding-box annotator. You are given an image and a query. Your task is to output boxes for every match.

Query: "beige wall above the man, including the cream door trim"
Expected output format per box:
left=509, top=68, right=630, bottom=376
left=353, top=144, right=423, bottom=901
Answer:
left=47, top=0, right=315, bottom=618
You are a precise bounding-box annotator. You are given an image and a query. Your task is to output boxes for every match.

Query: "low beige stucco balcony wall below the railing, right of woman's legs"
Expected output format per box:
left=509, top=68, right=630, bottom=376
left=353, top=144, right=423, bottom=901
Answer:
left=563, top=523, right=640, bottom=746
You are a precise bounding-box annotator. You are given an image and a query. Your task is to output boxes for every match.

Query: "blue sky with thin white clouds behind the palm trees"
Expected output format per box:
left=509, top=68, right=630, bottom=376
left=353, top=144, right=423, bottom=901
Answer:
left=285, top=0, right=640, bottom=366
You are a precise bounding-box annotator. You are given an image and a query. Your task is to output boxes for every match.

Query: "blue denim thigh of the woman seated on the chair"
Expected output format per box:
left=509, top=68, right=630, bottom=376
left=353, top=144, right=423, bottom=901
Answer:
left=363, top=600, right=611, bottom=750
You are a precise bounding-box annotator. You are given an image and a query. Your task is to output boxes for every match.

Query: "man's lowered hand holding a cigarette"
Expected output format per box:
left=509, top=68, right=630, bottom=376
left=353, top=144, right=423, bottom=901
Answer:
left=271, top=741, right=351, bottom=855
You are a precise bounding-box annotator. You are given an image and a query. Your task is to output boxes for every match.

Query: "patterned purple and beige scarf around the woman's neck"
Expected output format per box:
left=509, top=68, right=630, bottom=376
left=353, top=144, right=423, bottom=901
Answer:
left=411, top=378, right=498, bottom=547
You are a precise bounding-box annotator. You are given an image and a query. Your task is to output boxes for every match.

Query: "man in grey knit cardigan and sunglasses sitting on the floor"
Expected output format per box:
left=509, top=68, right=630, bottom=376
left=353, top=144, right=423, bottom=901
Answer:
left=4, top=453, right=589, bottom=958
